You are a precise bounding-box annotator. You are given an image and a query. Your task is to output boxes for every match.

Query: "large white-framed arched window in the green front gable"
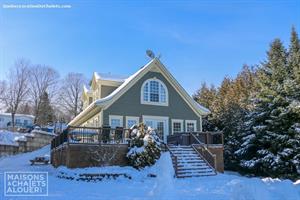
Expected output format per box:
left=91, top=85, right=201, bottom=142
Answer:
left=141, top=78, right=168, bottom=106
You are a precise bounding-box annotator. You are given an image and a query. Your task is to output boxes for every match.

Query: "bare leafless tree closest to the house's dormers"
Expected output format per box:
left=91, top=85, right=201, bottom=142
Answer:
left=60, top=73, right=86, bottom=118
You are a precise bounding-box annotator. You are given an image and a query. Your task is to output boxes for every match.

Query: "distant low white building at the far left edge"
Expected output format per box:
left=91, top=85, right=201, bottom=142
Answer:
left=0, top=113, right=34, bottom=129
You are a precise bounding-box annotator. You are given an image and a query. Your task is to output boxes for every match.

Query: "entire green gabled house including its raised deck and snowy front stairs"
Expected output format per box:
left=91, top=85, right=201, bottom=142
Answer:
left=51, top=58, right=224, bottom=175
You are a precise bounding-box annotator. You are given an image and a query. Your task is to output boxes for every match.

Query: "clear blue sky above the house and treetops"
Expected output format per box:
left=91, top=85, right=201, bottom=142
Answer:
left=0, top=0, right=300, bottom=94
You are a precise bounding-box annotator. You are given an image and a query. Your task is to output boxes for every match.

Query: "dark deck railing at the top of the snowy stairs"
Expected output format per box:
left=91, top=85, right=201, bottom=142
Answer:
left=167, top=132, right=223, bottom=145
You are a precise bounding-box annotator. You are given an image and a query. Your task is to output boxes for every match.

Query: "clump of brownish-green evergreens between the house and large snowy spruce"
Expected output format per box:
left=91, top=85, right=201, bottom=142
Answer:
left=194, top=66, right=254, bottom=170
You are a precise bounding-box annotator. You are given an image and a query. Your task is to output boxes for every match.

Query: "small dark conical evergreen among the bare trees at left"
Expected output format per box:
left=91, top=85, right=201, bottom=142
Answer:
left=36, top=92, right=54, bottom=126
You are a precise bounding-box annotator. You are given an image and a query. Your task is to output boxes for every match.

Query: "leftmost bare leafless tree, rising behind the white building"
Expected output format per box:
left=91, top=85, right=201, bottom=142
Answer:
left=3, top=59, right=29, bottom=129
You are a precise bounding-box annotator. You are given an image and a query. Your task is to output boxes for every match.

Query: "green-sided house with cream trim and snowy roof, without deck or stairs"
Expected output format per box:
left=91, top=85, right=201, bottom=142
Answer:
left=69, top=58, right=210, bottom=142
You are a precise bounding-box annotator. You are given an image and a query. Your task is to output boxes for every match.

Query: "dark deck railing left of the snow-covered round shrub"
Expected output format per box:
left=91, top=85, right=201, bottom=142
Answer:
left=51, top=126, right=130, bottom=149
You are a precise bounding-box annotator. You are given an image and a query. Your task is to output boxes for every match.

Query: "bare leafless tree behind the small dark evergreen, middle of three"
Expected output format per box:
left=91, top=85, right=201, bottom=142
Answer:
left=30, top=65, right=59, bottom=122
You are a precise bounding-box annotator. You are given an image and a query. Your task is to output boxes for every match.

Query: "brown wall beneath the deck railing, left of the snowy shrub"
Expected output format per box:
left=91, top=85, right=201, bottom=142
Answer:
left=51, top=144, right=128, bottom=168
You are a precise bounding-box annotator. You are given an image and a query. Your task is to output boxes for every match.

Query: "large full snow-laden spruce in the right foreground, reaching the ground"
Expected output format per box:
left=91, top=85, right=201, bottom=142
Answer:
left=236, top=33, right=300, bottom=178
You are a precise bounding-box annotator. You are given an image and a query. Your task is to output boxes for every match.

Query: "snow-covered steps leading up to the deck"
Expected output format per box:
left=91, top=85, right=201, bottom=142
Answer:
left=169, top=145, right=217, bottom=178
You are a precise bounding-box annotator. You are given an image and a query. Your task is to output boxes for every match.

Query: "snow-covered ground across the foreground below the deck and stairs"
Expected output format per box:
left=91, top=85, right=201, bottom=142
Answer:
left=0, top=146, right=300, bottom=200
